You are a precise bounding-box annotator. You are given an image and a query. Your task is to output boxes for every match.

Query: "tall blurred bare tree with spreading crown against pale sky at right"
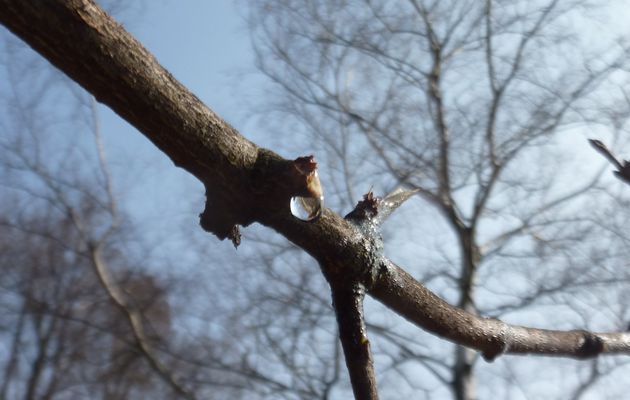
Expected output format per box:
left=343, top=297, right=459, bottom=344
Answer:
left=247, top=0, right=630, bottom=399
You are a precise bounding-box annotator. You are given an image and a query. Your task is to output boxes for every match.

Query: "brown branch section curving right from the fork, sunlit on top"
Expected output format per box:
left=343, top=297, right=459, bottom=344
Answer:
left=370, top=258, right=630, bottom=361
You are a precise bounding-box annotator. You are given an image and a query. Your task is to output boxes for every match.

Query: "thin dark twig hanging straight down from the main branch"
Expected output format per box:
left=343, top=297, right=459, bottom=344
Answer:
left=331, top=282, right=378, bottom=400
